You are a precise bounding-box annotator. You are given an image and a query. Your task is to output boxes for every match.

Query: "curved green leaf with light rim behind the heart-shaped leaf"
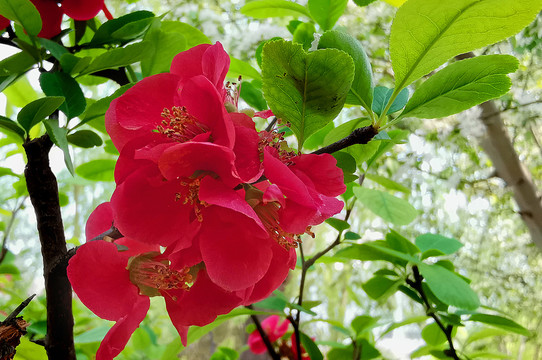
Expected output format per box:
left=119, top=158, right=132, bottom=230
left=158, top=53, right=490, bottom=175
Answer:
left=318, top=31, right=374, bottom=111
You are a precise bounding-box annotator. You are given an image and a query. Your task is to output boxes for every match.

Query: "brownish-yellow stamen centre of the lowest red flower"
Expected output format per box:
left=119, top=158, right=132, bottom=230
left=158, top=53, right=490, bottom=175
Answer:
left=126, top=252, right=193, bottom=300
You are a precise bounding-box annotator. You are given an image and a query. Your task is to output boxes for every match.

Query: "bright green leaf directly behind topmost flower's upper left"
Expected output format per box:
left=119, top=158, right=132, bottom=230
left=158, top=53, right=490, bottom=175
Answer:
left=141, top=30, right=187, bottom=77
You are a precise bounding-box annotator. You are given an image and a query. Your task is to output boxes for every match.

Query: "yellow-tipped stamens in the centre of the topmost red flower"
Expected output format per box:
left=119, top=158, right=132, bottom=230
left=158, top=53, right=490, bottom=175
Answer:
left=156, top=106, right=209, bottom=143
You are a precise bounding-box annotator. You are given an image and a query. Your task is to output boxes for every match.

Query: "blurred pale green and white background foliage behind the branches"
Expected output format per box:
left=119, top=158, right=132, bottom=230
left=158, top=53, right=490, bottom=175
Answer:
left=0, top=0, right=542, bottom=359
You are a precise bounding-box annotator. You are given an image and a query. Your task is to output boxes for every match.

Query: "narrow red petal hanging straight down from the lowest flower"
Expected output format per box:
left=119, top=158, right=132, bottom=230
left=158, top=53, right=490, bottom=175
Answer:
left=96, top=296, right=150, bottom=360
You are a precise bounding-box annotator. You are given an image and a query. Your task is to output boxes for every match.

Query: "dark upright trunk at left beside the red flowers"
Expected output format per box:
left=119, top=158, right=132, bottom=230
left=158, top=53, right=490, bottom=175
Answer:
left=23, top=135, right=75, bottom=360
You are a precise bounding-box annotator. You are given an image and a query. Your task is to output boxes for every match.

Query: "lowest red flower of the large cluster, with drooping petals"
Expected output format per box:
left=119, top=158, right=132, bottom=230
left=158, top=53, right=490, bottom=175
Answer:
left=68, top=203, right=245, bottom=360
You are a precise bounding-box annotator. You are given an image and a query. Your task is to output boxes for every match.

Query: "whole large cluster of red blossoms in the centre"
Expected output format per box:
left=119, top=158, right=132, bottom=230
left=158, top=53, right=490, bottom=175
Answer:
left=68, top=43, right=345, bottom=360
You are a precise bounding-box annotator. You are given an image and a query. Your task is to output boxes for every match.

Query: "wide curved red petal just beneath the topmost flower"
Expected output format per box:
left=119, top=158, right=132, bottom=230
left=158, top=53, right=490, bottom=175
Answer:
left=158, top=142, right=239, bottom=188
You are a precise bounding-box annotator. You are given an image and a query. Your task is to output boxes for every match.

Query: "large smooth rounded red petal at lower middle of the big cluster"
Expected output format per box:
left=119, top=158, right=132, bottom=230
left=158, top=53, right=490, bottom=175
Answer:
left=200, top=207, right=273, bottom=291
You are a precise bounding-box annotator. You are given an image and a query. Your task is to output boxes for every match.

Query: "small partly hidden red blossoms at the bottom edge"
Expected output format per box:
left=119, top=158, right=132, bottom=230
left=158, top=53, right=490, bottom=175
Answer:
left=248, top=315, right=311, bottom=360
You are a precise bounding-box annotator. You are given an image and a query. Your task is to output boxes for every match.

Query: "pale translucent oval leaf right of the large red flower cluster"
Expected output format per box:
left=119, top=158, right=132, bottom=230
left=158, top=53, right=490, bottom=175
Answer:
left=354, top=187, right=418, bottom=225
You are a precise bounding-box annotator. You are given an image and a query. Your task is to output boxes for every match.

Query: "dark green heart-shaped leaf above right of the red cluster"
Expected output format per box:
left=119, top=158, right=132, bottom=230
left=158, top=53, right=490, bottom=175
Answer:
left=264, top=39, right=354, bottom=148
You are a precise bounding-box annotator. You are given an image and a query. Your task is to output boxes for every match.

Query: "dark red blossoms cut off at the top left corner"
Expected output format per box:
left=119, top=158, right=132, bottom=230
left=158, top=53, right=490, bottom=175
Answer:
left=0, top=0, right=112, bottom=39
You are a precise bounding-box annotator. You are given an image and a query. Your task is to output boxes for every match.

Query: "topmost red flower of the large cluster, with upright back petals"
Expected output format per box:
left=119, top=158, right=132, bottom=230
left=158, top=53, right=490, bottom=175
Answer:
left=105, top=43, right=235, bottom=152
